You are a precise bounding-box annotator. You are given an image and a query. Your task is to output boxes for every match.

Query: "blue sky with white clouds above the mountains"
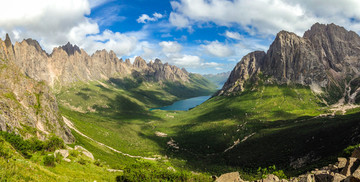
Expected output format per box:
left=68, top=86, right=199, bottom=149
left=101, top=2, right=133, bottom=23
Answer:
left=0, top=0, right=360, bottom=74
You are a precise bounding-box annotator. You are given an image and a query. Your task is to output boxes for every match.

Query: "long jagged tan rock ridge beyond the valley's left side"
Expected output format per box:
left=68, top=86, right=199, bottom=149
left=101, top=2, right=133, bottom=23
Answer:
left=9, top=39, right=189, bottom=87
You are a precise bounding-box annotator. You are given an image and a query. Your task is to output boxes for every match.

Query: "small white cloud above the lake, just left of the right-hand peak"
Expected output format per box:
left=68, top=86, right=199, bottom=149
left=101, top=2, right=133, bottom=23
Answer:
left=201, top=40, right=234, bottom=57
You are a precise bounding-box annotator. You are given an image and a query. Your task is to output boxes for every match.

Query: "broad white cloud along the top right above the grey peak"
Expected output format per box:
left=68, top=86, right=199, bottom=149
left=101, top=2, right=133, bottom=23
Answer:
left=169, top=0, right=360, bottom=36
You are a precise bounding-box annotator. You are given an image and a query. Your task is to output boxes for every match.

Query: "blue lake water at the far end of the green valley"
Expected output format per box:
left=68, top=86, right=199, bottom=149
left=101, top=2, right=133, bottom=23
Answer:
left=150, top=96, right=211, bottom=111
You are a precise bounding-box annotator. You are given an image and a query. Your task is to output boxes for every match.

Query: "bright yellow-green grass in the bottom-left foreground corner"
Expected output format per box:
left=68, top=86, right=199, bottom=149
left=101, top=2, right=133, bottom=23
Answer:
left=0, top=134, right=121, bottom=181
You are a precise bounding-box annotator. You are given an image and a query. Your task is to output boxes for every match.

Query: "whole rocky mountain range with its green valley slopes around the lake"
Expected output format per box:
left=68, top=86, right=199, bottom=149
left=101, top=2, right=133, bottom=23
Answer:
left=0, top=23, right=360, bottom=181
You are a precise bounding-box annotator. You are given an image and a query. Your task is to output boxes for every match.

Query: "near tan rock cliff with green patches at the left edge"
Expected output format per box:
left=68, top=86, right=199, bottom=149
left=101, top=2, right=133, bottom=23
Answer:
left=0, top=38, right=74, bottom=143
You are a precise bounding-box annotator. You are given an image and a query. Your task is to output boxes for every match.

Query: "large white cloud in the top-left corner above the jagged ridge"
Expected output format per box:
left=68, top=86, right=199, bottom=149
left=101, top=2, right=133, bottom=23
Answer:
left=0, top=0, right=138, bottom=56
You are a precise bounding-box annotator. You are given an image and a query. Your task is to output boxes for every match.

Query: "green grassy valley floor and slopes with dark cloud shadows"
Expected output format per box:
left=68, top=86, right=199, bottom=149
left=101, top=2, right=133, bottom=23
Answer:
left=58, top=75, right=360, bottom=179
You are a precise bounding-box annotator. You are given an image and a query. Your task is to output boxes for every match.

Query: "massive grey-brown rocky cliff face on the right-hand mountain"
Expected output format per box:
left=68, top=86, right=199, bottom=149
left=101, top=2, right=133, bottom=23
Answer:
left=218, top=23, right=360, bottom=103
